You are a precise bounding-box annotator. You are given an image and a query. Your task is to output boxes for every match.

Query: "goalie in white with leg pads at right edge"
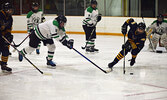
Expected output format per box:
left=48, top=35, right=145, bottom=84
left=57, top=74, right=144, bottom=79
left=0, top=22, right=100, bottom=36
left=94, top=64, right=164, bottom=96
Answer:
left=147, top=14, right=167, bottom=51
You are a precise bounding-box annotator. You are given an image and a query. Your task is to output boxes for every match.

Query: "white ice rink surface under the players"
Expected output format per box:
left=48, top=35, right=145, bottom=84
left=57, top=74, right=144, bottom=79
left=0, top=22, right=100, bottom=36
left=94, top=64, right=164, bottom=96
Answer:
left=0, top=34, right=167, bottom=100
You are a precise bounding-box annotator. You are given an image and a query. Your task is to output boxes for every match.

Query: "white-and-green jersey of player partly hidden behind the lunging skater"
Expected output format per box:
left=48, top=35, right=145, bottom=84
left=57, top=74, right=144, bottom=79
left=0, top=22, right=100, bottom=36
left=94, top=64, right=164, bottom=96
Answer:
left=27, top=9, right=43, bottom=29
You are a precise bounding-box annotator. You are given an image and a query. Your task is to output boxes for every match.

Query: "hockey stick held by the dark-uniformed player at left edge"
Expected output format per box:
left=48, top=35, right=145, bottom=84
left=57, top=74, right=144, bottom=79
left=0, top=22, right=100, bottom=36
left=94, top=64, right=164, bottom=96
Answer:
left=2, top=36, right=51, bottom=75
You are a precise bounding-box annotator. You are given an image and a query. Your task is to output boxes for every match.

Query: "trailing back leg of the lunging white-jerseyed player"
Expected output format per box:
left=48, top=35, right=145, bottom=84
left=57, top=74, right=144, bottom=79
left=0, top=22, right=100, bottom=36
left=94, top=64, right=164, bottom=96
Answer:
left=19, top=31, right=41, bottom=61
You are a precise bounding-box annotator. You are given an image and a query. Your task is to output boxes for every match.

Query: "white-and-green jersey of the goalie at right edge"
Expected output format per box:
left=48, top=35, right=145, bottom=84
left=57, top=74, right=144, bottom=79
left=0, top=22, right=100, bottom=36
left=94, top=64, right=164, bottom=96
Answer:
left=148, top=20, right=167, bottom=35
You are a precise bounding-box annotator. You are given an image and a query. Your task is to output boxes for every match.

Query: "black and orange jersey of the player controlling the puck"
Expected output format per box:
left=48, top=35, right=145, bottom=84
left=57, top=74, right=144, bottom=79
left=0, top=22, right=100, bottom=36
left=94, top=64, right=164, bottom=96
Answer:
left=123, top=19, right=146, bottom=49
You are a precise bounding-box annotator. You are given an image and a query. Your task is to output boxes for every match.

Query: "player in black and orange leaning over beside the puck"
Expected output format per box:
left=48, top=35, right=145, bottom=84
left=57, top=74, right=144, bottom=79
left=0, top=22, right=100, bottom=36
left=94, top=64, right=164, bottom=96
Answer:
left=108, top=19, right=146, bottom=71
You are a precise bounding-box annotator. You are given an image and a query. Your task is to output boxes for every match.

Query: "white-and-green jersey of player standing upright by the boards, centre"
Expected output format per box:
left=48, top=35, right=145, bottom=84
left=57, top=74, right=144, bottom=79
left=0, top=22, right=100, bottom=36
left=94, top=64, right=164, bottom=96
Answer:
left=83, top=6, right=99, bottom=27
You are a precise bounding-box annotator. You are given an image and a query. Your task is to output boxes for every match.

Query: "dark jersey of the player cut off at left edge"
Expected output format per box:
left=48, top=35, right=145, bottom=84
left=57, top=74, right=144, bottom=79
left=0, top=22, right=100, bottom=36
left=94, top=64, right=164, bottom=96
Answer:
left=0, top=10, right=13, bottom=35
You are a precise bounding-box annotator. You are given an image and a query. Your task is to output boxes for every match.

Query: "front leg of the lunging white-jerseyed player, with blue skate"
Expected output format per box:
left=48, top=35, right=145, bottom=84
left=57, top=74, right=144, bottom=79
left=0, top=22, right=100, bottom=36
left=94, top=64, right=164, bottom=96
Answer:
left=43, top=39, right=56, bottom=68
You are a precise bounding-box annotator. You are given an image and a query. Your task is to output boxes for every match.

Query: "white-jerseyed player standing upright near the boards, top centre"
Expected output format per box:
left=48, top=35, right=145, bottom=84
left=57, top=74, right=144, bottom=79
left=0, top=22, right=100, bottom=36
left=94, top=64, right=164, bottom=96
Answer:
left=83, top=0, right=101, bottom=52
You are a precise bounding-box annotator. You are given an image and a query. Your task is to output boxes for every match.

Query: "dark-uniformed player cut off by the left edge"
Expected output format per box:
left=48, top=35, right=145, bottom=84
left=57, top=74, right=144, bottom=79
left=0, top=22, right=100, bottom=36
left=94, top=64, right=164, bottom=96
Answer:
left=0, top=3, right=13, bottom=72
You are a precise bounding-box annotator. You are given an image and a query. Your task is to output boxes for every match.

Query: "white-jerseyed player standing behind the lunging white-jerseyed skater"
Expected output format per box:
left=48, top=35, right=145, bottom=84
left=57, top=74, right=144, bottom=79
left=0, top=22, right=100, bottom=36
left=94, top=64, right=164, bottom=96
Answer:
left=27, top=2, right=45, bottom=54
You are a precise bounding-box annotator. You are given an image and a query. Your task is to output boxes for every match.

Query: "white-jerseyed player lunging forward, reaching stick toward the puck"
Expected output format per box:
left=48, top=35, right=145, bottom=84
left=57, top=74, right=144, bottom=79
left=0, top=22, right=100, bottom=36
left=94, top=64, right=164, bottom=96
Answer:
left=19, top=15, right=74, bottom=68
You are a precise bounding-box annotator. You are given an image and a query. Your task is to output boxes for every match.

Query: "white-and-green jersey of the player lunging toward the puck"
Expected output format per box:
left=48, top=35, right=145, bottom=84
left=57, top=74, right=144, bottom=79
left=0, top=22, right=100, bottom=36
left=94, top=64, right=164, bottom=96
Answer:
left=34, top=20, right=67, bottom=41
